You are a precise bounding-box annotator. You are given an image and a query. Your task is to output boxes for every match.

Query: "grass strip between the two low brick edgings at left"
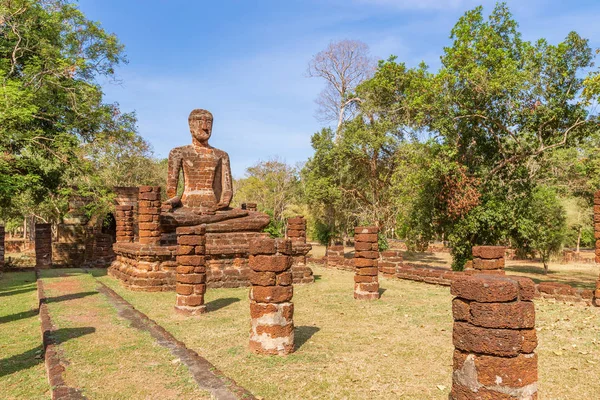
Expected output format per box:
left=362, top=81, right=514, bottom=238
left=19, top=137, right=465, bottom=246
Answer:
left=38, top=270, right=210, bottom=399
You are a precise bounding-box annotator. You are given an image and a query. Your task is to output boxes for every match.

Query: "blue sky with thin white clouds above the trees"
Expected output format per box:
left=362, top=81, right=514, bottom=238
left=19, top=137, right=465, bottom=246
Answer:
left=79, top=0, right=600, bottom=178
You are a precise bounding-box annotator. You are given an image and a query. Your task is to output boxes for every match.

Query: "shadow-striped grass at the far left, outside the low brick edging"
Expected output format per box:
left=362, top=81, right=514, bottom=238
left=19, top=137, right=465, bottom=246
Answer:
left=0, top=271, right=50, bottom=399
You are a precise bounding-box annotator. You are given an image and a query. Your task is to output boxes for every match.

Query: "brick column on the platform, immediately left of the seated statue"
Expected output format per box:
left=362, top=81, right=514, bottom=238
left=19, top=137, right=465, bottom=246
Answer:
left=138, top=186, right=161, bottom=244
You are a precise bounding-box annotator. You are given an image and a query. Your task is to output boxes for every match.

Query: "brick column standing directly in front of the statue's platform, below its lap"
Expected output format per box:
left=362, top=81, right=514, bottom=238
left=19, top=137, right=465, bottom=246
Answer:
left=175, top=225, right=206, bottom=315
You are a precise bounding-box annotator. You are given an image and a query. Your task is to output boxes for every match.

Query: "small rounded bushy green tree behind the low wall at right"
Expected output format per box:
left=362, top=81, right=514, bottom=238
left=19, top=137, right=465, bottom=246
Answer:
left=518, top=186, right=567, bottom=275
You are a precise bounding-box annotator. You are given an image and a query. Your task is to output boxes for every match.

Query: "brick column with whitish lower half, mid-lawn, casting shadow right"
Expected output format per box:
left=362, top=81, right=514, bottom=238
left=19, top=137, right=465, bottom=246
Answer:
left=249, top=238, right=294, bottom=355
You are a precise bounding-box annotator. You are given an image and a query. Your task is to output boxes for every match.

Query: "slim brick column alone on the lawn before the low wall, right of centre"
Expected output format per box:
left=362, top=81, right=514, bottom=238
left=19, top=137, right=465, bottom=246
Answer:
left=354, top=226, right=379, bottom=300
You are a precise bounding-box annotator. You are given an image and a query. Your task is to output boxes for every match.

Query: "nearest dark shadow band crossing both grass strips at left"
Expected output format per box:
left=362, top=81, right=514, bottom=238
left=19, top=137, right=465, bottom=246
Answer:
left=0, top=326, right=96, bottom=377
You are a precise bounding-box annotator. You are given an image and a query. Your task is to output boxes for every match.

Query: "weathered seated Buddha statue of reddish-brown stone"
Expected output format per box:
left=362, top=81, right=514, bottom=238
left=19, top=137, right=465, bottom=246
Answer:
left=161, top=109, right=269, bottom=232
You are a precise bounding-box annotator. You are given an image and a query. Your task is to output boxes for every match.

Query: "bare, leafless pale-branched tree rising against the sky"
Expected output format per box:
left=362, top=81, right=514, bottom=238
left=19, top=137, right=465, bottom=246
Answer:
left=307, top=40, right=375, bottom=134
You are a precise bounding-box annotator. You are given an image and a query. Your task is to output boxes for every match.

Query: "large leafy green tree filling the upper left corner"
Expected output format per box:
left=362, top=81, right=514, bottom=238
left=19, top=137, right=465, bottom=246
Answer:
left=0, top=0, right=149, bottom=225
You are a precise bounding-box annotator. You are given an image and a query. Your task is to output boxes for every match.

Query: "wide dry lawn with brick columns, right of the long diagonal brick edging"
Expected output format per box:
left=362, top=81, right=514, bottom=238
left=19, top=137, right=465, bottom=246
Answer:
left=99, top=266, right=600, bottom=399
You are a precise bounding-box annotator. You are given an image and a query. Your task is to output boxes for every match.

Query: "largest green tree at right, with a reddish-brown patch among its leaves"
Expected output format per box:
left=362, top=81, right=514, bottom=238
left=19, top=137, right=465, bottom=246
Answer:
left=358, top=3, right=599, bottom=269
